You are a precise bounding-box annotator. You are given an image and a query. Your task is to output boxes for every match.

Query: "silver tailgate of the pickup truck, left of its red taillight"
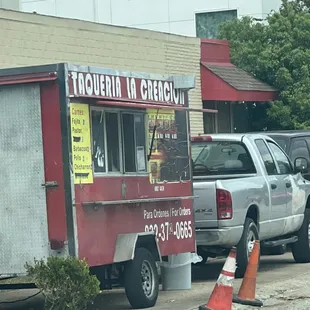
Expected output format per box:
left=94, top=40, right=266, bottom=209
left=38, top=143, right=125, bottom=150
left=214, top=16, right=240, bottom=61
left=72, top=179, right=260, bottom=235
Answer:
left=193, top=180, right=218, bottom=228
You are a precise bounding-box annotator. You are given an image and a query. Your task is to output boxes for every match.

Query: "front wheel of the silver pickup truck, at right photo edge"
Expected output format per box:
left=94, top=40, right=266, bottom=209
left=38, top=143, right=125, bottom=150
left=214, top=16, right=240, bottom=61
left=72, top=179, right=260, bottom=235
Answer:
left=292, top=209, right=310, bottom=263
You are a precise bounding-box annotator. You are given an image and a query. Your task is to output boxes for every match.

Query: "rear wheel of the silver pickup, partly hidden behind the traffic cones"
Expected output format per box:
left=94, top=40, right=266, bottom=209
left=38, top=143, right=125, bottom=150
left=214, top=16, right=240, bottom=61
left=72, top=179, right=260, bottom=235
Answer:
left=236, top=218, right=259, bottom=278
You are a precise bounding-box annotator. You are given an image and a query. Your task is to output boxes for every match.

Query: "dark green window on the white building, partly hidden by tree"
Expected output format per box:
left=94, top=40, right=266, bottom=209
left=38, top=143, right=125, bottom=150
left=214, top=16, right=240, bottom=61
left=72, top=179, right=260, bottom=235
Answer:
left=196, top=10, right=238, bottom=39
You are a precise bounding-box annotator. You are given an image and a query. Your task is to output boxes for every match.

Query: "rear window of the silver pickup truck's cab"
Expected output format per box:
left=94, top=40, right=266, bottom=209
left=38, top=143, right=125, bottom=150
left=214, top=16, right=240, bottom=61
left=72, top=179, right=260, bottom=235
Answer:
left=192, top=141, right=256, bottom=176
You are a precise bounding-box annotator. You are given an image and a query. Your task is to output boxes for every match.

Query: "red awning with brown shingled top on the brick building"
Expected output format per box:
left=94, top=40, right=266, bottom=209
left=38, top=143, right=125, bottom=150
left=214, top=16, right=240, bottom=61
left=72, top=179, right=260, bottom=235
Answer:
left=201, top=62, right=278, bottom=102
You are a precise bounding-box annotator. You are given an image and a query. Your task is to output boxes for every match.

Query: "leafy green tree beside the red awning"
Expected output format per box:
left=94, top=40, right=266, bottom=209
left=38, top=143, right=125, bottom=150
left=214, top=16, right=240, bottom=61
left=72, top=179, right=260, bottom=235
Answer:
left=219, top=0, right=310, bottom=130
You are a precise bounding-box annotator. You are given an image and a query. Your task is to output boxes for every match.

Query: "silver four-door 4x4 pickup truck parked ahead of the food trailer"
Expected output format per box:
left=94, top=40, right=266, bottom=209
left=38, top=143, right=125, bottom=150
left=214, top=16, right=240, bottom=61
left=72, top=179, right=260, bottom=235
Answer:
left=192, top=134, right=310, bottom=277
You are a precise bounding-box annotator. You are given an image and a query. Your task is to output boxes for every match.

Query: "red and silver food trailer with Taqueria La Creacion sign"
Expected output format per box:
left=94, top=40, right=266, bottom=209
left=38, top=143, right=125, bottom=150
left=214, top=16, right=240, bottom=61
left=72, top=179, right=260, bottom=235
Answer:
left=0, top=64, right=201, bottom=308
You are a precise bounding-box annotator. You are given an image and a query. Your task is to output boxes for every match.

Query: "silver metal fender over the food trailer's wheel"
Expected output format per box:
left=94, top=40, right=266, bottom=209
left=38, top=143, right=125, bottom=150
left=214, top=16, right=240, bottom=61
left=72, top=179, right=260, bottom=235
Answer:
left=113, top=232, right=161, bottom=263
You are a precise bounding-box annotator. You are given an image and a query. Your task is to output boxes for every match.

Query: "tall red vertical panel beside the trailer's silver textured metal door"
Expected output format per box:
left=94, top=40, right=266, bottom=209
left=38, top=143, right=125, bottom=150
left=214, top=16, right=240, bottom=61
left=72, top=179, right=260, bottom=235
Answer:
left=41, top=83, right=68, bottom=251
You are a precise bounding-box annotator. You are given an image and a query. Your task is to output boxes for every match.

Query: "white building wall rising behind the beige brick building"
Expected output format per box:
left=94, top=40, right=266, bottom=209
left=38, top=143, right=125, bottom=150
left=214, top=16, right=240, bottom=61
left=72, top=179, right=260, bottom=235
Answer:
left=21, top=0, right=281, bottom=36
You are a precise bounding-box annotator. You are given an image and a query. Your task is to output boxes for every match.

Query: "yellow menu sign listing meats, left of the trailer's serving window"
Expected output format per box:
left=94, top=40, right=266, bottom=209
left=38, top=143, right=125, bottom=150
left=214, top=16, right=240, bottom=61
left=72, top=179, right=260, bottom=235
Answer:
left=70, top=103, right=94, bottom=184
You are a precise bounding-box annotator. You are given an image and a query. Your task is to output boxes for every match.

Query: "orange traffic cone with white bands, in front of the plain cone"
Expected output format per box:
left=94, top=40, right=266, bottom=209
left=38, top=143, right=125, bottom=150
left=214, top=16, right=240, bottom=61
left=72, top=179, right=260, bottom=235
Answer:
left=199, top=248, right=236, bottom=310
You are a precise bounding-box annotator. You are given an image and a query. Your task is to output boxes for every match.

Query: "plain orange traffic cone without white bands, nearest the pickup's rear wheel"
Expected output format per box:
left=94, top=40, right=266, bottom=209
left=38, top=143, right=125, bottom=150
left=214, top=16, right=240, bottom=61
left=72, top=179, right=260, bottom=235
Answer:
left=233, top=240, right=263, bottom=307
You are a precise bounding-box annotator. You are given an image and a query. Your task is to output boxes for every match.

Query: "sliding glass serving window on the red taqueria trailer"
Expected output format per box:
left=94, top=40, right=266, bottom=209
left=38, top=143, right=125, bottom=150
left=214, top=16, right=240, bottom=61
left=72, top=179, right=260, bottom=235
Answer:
left=91, top=108, right=147, bottom=174
